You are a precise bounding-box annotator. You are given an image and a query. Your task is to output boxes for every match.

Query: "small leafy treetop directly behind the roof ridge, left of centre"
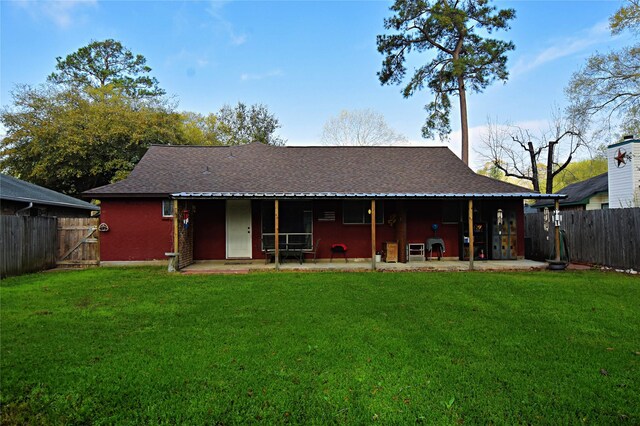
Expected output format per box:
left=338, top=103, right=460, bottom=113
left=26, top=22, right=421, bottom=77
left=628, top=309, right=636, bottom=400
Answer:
left=214, top=102, right=286, bottom=145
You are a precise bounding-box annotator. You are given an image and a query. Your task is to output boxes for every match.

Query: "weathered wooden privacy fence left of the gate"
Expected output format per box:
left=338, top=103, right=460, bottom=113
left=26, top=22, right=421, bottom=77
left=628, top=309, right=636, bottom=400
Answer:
left=0, top=215, right=57, bottom=277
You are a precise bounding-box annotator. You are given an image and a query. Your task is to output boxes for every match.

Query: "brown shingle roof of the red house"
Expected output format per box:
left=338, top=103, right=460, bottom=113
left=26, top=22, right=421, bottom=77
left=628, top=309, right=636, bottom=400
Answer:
left=83, top=143, right=556, bottom=198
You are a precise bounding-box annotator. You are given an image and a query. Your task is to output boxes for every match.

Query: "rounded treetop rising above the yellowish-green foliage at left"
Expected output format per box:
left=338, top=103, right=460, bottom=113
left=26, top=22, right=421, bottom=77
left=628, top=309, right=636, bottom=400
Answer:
left=48, top=39, right=165, bottom=99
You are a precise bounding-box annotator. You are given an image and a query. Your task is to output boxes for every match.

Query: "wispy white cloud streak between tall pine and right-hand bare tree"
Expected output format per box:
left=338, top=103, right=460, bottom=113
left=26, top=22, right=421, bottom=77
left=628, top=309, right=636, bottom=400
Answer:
left=511, top=21, right=611, bottom=77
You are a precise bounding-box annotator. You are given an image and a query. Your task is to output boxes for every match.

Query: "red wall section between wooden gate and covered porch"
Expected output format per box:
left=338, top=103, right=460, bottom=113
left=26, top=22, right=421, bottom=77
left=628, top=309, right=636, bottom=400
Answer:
left=100, top=199, right=173, bottom=261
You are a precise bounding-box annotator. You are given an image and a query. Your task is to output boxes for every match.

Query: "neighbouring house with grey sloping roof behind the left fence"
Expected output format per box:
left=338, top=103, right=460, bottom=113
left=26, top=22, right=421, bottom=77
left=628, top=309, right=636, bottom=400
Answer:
left=0, top=173, right=100, bottom=217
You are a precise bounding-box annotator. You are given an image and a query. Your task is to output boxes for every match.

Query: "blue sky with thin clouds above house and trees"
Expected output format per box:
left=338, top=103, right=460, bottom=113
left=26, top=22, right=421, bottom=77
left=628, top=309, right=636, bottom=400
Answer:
left=0, top=0, right=624, bottom=165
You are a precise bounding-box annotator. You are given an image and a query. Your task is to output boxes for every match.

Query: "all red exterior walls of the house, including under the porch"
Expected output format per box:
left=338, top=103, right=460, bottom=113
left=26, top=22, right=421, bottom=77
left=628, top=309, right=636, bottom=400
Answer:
left=100, top=199, right=524, bottom=261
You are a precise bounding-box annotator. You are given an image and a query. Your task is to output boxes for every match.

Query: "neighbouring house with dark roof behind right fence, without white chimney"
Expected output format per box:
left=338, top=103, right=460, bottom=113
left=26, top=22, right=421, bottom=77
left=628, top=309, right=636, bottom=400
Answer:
left=532, top=173, right=609, bottom=211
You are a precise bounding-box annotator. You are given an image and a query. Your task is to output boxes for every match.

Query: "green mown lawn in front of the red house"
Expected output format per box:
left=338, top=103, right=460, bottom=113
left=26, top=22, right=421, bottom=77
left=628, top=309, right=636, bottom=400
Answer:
left=0, top=268, right=640, bottom=424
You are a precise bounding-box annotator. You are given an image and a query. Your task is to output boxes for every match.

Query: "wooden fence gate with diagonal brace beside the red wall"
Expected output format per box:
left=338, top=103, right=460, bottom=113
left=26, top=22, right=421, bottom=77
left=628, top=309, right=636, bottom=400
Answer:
left=56, top=217, right=100, bottom=266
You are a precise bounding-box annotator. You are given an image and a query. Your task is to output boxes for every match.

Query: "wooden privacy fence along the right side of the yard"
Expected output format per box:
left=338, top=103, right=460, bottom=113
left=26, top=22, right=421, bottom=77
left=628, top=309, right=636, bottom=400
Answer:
left=525, top=208, right=640, bottom=270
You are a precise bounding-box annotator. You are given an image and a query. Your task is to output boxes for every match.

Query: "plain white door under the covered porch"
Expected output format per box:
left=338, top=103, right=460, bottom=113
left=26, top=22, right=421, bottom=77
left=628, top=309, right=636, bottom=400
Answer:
left=227, top=200, right=251, bottom=259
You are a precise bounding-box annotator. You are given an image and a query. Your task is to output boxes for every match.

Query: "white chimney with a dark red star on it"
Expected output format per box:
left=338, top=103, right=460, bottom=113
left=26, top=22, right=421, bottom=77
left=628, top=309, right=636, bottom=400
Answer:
left=607, top=136, right=640, bottom=209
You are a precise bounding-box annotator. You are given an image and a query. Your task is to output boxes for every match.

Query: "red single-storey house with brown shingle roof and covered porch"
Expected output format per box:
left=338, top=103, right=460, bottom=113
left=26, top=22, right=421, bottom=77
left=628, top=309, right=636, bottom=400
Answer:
left=83, top=143, right=562, bottom=267
